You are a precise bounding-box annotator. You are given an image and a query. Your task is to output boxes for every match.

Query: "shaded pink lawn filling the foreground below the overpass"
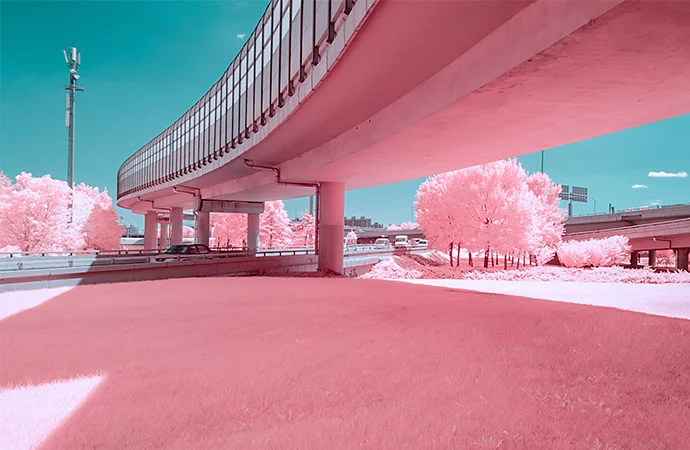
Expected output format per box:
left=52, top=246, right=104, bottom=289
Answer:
left=0, top=277, right=690, bottom=450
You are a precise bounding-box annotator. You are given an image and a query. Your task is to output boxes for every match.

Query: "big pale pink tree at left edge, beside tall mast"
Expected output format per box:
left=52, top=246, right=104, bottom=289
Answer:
left=0, top=172, right=83, bottom=252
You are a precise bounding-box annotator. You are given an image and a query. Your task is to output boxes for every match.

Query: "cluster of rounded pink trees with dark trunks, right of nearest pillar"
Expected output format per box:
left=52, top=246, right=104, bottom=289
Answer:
left=416, top=160, right=565, bottom=267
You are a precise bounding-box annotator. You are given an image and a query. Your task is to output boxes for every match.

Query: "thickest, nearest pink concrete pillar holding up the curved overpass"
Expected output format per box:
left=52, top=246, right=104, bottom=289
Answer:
left=318, top=183, right=345, bottom=274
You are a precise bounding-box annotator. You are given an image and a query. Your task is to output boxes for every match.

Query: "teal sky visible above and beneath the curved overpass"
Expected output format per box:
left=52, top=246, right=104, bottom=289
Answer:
left=0, top=0, right=690, bottom=230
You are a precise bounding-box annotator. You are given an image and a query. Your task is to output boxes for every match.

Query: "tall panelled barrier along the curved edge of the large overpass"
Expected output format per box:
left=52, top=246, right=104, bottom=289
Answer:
left=117, top=0, right=364, bottom=199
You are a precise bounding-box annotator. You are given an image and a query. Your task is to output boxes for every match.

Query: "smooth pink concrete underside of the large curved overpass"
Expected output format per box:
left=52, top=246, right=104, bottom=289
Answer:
left=119, top=0, right=690, bottom=212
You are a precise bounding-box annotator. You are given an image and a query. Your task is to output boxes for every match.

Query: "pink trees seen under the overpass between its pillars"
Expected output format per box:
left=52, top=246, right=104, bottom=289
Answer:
left=211, top=200, right=316, bottom=248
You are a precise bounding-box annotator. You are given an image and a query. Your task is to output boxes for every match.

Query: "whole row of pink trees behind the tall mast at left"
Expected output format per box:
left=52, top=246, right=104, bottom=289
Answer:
left=0, top=173, right=124, bottom=252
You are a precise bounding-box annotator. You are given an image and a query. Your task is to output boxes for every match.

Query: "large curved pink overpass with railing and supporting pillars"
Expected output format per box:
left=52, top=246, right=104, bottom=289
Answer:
left=118, top=0, right=690, bottom=272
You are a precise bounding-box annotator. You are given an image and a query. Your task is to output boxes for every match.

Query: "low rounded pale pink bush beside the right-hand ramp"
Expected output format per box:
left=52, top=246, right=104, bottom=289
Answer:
left=558, top=236, right=630, bottom=267
